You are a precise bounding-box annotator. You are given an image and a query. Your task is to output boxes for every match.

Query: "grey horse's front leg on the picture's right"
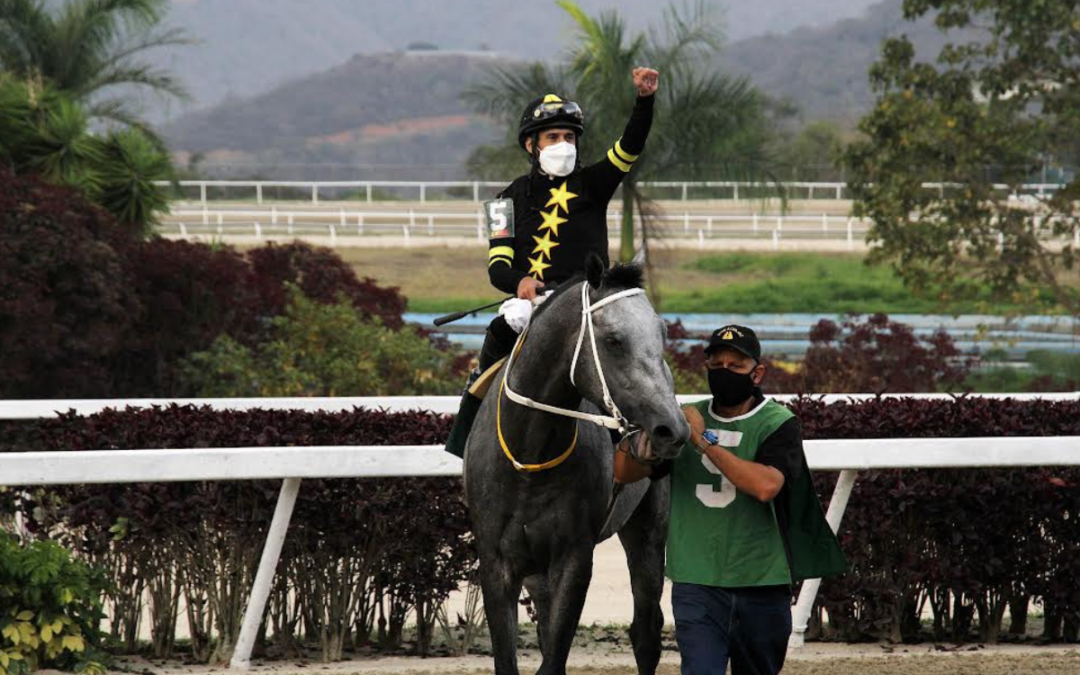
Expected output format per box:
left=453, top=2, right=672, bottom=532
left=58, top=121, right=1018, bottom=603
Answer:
left=537, top=542, right=593, bottom=675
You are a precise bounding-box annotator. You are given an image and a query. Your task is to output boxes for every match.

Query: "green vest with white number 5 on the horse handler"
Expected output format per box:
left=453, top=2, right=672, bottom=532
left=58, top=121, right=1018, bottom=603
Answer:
left=666, top=400, right=848, bottom=588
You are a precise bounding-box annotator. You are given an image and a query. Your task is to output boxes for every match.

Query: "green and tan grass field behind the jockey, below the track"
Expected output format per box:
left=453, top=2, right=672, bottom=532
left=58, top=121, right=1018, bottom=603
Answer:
left=337, top=247, right=1054, bottom=314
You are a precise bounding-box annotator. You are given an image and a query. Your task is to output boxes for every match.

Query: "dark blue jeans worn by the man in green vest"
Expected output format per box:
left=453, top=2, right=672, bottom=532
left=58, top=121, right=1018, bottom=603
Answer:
left=672, top=583, right=792, bottom=675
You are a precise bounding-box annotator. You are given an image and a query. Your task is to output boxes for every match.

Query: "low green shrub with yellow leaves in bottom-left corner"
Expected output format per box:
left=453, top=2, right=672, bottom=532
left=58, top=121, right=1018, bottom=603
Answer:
left=0, top=534, right=105, bottom=675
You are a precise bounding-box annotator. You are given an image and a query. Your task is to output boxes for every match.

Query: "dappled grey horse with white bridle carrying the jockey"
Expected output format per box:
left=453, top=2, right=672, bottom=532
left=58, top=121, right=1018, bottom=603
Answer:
left=464, top=256, right=690, bottom=675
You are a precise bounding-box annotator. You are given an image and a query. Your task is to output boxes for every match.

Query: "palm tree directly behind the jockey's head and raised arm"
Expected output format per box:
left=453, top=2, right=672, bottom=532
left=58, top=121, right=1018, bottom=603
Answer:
left=467, top=0, right=770, bottom=260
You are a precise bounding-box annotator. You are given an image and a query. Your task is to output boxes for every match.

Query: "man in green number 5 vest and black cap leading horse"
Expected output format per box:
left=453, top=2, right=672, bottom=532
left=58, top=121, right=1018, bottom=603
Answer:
left=615, top=325, right=848, bottom=675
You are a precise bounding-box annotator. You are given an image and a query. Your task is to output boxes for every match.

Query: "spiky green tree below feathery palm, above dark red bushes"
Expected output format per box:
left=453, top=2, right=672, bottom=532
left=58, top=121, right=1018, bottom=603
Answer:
left=0, top=73, right=173, bottom=237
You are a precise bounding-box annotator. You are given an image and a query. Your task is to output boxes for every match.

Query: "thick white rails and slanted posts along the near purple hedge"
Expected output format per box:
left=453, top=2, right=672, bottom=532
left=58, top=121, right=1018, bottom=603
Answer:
left=0, top=392, right=1080, bottom=669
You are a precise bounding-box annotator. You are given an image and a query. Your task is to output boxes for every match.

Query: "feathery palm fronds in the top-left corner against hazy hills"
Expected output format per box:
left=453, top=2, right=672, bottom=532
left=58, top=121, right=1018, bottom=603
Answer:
left=0, top=0, right=191, bottom=129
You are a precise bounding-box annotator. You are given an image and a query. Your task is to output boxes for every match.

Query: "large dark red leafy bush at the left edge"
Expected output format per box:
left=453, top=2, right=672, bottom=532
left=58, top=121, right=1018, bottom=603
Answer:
left=0, top=166, right=143, bottom=399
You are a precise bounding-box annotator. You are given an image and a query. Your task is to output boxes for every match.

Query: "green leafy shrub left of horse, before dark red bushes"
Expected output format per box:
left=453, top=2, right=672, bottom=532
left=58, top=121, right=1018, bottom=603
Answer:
left=183, top=287, right=460, bottom=396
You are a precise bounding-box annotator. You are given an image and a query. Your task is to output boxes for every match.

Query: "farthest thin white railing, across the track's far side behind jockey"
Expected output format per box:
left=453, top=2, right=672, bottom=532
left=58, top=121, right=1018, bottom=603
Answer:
left=157, top=180, right=1063, bottom=204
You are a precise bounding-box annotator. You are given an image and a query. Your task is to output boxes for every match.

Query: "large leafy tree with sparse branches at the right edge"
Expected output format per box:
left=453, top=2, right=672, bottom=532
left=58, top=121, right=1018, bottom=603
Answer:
left=846, top=0, right=1080, bottom=315
